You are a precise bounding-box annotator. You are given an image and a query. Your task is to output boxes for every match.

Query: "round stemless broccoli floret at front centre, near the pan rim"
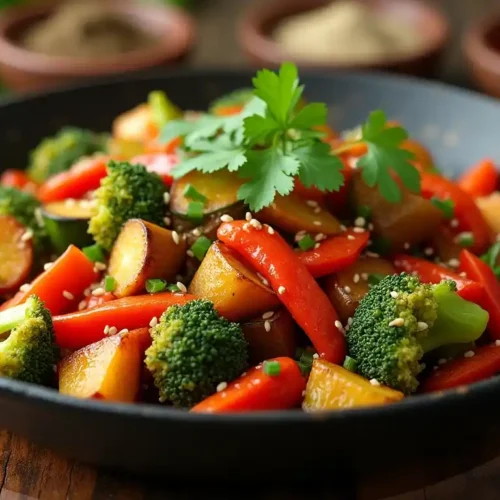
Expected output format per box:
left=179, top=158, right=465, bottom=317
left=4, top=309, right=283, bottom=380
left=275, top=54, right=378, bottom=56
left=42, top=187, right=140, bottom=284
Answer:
left=146, top=300, right=248, bottom=408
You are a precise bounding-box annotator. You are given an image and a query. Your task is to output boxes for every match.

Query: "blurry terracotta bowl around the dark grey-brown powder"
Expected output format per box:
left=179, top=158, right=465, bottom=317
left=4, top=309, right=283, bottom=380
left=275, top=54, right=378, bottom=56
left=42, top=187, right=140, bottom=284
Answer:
left=0, top=0, right=195, bottom=92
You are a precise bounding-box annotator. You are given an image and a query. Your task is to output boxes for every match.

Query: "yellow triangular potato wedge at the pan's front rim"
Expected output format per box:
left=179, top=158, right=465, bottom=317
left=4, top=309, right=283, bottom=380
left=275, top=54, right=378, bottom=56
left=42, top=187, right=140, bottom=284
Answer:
left=302, top=359, right=404, bottom=412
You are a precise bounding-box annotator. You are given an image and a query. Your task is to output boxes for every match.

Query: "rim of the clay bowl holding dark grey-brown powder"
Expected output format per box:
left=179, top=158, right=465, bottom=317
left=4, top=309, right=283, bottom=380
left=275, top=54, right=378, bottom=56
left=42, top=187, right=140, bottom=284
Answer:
left=0, top=0, right=196, bottom=76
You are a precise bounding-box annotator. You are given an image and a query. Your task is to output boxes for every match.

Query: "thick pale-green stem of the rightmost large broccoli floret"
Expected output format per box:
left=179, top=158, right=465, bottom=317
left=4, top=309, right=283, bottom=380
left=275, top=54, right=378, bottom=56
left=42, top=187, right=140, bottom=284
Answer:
left=420, top=283, right=489, bottom=353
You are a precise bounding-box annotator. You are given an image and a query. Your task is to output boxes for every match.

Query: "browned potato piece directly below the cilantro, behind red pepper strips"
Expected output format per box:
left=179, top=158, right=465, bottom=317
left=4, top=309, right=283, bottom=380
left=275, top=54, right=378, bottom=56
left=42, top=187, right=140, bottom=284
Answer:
left=256, top=193, right=340, bottom=236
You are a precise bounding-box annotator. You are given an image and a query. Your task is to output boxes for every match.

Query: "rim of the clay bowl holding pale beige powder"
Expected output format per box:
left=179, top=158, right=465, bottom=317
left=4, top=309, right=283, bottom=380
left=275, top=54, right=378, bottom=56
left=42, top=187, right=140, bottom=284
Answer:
left=238, top=0, right=451, bottom=70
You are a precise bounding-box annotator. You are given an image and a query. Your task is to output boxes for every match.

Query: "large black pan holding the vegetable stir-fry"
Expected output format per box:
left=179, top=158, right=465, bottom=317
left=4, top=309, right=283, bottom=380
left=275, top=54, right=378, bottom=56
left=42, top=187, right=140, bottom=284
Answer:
left=0, top=71, right=500, bottom=496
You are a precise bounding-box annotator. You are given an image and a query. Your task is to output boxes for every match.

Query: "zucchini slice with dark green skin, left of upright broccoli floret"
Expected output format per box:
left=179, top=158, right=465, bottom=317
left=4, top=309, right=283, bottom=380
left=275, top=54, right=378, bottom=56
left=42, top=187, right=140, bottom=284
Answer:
left=42, top=200, right=93, bottom=252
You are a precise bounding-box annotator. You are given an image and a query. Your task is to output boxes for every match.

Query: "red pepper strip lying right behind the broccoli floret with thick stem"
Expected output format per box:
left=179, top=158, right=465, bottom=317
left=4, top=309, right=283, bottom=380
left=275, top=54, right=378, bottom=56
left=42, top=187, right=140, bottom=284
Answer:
left=393, top=254, right=484, bottom=304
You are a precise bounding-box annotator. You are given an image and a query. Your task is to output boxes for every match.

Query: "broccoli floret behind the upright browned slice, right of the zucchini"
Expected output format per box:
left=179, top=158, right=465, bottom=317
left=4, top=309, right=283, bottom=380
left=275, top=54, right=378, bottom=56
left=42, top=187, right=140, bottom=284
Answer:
left=89, top=161, right=165, bottom=250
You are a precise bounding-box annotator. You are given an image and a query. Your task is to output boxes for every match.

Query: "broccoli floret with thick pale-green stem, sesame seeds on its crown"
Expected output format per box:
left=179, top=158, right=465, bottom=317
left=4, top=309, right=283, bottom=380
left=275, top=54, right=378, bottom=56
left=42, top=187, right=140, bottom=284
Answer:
left=346, top=273, right=488, bottom=394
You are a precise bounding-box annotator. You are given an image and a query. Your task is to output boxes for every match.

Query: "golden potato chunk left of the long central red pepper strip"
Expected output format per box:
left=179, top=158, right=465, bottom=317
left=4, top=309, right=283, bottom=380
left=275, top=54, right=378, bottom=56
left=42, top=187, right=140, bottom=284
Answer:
left=189, top=242, right=280, bottom=321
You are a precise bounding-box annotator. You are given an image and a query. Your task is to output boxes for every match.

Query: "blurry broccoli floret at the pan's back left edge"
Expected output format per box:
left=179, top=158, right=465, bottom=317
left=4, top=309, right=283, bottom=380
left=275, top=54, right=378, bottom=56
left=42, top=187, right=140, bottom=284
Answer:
left=28, top=127, right=108, bottom=182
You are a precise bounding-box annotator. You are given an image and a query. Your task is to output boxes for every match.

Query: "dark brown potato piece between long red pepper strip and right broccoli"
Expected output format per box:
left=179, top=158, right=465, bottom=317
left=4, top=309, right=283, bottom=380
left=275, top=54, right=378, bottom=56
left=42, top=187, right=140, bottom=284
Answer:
left=323, top=257, right=396, bottom=324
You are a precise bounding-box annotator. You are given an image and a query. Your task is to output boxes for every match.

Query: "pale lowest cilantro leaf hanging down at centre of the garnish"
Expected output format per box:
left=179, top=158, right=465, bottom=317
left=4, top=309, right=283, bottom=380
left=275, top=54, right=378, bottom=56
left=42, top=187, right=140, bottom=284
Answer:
left=238, top=148, right=300, bottom=211
